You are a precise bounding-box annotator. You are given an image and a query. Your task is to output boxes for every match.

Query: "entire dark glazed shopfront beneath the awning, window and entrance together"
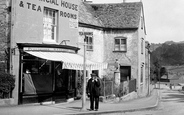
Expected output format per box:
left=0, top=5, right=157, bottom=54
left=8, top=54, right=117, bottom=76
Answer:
left=21, top=52, right=76, bottom=103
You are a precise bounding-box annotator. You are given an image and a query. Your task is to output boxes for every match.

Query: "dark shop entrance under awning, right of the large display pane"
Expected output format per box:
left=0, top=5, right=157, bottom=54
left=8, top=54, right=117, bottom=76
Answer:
left=54, top=62, right=76, bottom=103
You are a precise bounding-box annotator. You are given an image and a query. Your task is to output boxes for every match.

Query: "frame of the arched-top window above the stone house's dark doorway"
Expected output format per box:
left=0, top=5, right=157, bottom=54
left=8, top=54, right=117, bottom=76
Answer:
left=114, top=36, right=127, bottom=52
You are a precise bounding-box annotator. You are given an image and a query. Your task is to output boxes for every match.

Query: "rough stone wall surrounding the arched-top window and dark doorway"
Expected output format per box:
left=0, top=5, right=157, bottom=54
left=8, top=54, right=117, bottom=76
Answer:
left=104, top=30, right=138, bottom=79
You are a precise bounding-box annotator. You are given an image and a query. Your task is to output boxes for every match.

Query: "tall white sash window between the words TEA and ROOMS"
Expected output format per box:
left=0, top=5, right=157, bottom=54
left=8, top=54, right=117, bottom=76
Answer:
left=43, top=8, right=58, bottom=42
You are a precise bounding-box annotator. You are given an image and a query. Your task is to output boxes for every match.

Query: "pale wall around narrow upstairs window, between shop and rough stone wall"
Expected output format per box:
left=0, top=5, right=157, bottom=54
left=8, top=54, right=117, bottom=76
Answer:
left=78, top=27, right=105, bottom=77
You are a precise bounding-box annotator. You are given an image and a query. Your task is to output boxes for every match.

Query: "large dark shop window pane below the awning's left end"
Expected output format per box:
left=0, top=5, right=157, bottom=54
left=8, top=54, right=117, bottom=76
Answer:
left=21, top=54, right=53, bottom=95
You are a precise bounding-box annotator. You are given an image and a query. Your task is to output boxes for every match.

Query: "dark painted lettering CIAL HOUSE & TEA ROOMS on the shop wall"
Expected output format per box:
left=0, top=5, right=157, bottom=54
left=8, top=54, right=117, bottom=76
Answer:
left=19, top=0, right=79, bottom=19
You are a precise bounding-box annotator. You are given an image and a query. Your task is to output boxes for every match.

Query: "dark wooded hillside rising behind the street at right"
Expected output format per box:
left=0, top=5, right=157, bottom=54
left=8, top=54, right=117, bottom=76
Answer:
left=151, top=41, right=184, bottom=66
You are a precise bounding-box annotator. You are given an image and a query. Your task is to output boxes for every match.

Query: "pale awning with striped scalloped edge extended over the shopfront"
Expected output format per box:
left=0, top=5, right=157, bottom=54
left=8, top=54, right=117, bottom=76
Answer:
left=25, top=51, right=107, bottom=70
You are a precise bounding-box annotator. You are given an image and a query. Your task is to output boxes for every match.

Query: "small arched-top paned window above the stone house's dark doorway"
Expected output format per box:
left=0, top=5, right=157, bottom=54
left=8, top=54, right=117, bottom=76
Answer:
left=114, top=37, right=127, bottom=51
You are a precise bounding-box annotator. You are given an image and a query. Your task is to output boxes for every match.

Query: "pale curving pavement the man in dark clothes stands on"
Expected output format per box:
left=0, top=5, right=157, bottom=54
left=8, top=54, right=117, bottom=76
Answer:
left=0, top=89, right=160, bottom=115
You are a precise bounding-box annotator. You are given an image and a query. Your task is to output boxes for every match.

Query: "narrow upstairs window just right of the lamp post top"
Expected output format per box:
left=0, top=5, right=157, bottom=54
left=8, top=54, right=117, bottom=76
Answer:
left=84, top=32, right=93, bottom=51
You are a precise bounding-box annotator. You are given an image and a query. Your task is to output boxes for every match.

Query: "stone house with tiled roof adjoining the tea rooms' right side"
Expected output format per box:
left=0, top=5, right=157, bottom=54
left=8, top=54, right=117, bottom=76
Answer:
left=78, top=2, right=147, bottom=96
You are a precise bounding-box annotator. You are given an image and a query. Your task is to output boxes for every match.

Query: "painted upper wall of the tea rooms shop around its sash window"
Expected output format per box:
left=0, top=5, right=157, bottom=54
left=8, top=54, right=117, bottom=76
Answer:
left=13, top=0, right=79, bottom=46
